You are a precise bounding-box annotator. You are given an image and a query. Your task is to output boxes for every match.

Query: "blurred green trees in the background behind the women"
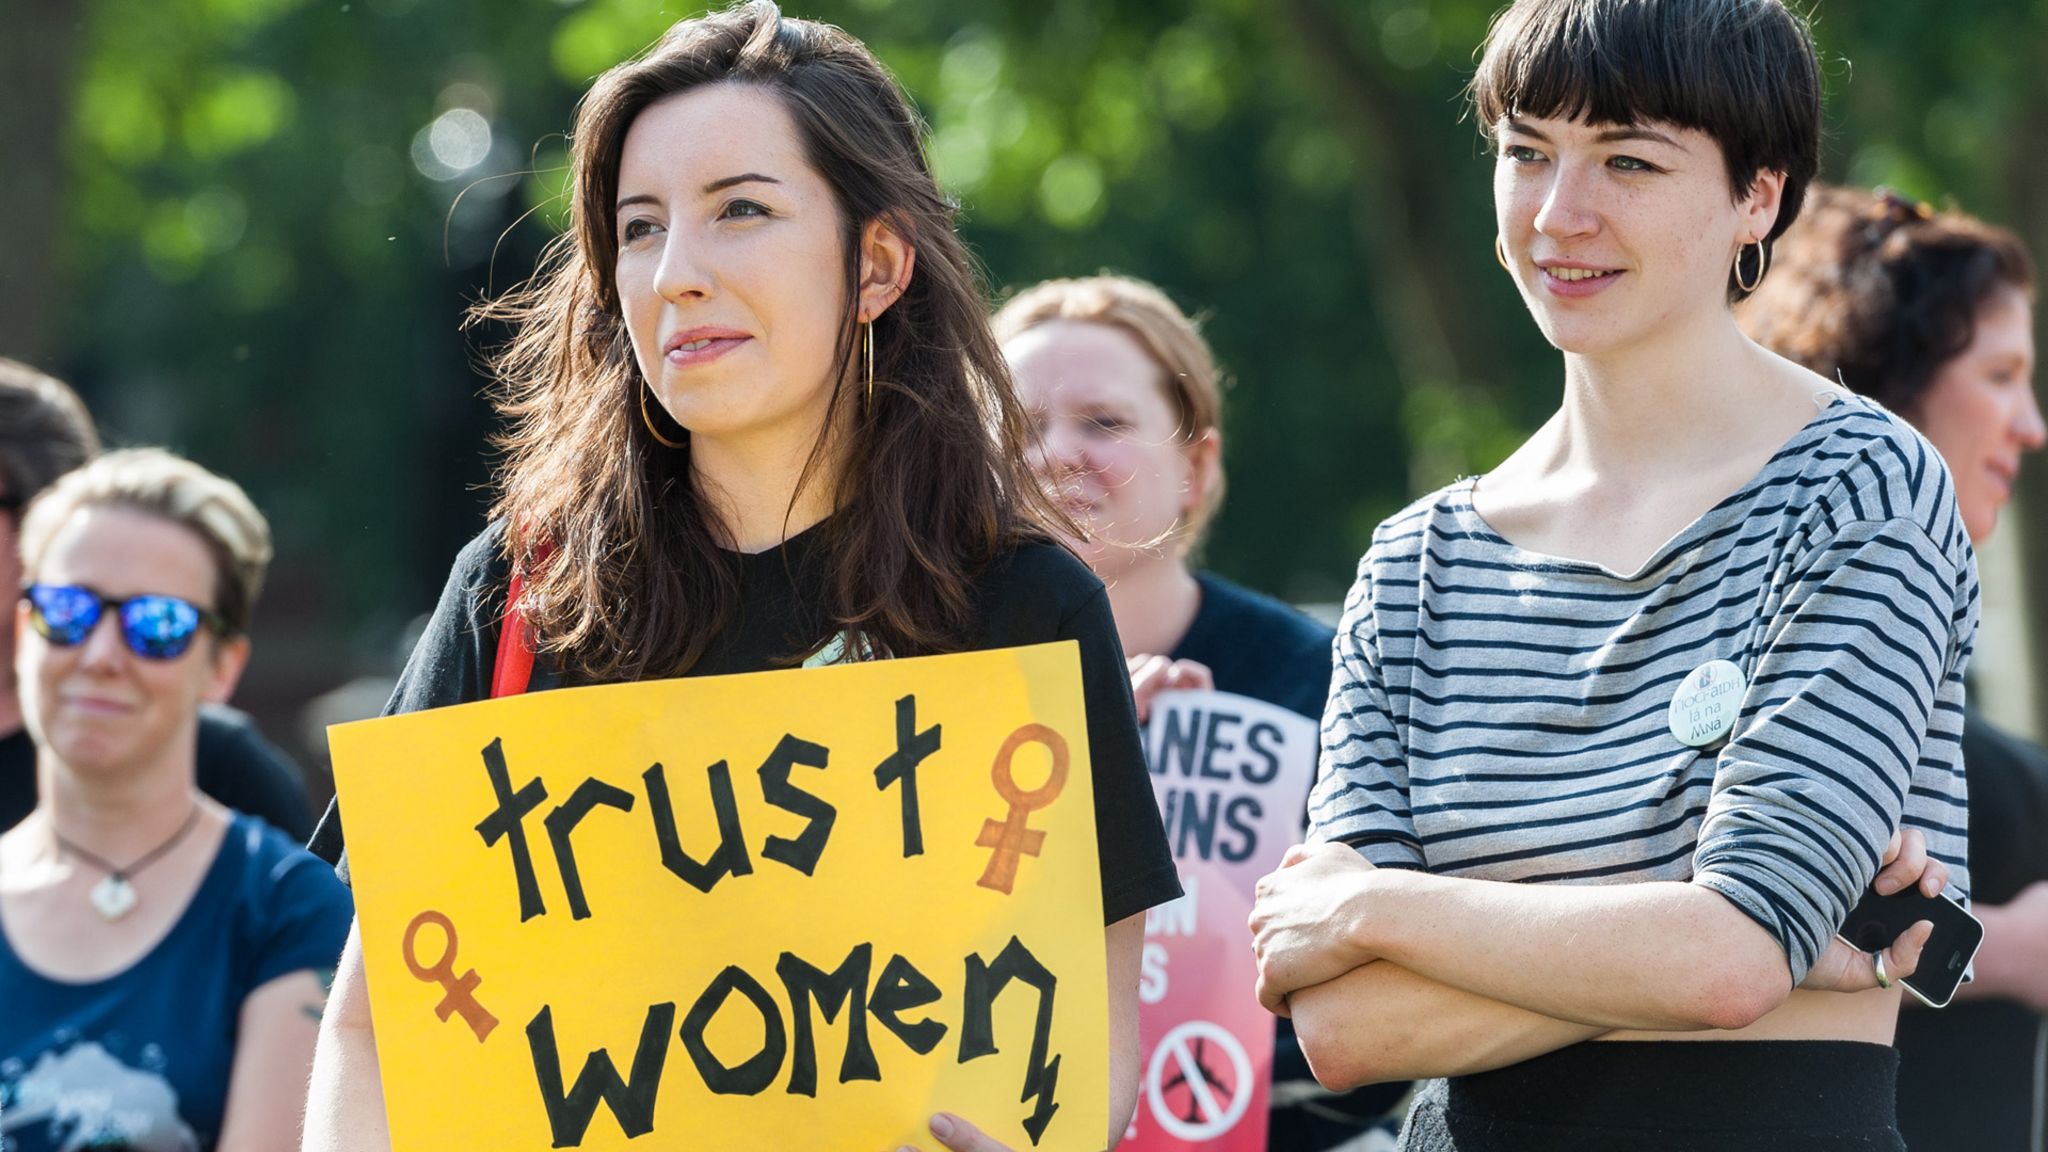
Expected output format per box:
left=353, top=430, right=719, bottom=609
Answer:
left=0, top=0, right=2048, bottom=778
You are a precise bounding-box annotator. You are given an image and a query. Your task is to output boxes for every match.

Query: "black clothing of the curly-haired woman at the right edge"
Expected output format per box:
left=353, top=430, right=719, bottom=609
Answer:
left=1896, top=709, right=2048, bottom=1152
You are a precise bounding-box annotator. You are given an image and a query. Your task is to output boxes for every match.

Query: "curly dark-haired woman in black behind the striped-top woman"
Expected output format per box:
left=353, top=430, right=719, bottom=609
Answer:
left=1739, top=187, right=2048, bottom=1152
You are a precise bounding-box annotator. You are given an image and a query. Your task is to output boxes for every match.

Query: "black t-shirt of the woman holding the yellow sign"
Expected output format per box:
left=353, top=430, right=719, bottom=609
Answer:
left=309, top=525, right=1180, bottom=922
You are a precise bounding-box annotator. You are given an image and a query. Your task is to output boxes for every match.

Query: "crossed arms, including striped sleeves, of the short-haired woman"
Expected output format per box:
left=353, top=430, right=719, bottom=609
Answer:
left=1286, top=510, right=1974, bottom=1086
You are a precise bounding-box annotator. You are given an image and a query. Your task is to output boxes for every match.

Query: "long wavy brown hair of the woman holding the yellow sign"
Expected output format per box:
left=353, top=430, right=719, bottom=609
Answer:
left=473, top=0, right=1063, bottom=681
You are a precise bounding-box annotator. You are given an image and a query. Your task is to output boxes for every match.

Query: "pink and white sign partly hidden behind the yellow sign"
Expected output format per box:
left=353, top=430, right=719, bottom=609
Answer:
left=1120, top=693, right=1317, bottom=1152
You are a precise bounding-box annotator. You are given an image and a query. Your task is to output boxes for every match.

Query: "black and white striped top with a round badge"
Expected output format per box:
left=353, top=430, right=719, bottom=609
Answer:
left=1311, top=398, right=1978, bottom=984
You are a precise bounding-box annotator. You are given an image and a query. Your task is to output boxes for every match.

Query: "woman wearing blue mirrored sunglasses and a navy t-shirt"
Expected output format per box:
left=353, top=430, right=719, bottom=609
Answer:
left=0, top=449, right=350, bottom=1152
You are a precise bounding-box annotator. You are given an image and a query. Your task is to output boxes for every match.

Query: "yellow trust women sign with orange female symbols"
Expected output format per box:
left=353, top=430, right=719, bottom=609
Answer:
left=330, top=642, right=1108, bottom=1152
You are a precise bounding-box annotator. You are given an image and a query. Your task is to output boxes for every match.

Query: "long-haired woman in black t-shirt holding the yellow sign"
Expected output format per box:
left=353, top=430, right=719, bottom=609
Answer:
left=307, top=0, right=1180, bottom=1150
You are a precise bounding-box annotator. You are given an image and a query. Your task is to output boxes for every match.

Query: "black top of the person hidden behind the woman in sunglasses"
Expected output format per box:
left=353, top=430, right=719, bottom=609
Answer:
left=0, top=705, right=313, bottom=840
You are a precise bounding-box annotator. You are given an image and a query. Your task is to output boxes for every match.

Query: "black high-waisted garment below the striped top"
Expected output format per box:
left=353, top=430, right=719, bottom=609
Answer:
left=1401, top=1039, right=1905, bottom=1152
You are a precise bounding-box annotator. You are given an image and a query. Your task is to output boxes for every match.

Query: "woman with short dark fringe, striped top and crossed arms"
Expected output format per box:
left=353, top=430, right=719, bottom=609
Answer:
left=1253, top=0, right=1976, bottom=1152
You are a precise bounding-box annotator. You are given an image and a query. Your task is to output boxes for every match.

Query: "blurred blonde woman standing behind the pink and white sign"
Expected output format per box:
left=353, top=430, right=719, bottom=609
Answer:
left=995, top=275, right=1405, bottom=1152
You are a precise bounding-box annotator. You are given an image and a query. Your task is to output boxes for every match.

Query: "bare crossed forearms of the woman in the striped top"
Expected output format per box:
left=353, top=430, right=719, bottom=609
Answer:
left=1251, top=832, right=1948, bottom=1088
